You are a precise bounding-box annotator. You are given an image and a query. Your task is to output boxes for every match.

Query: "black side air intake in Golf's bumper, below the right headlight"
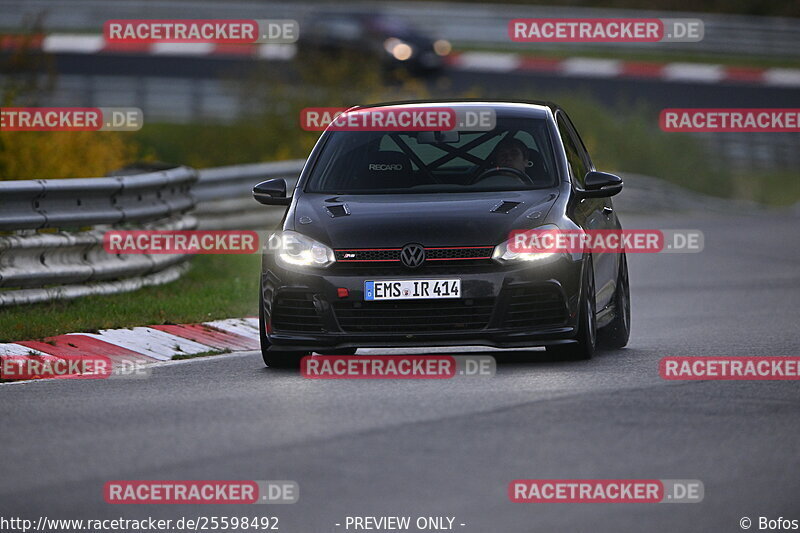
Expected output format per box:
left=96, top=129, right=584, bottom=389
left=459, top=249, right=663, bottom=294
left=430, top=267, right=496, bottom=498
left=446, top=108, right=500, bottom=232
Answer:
left=503, top=285, right=567, bottom=328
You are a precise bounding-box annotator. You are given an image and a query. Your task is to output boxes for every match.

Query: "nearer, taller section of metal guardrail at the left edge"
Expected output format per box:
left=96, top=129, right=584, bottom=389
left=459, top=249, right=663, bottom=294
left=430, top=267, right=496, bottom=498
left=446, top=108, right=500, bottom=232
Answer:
left=0, top=167, right=197, bottom=307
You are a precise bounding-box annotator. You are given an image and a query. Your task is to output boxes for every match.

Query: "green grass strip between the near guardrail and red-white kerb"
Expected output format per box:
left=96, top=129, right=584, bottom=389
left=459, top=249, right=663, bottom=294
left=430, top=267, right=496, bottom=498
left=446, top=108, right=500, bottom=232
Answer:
left=0, top=254, right=260, bottom=342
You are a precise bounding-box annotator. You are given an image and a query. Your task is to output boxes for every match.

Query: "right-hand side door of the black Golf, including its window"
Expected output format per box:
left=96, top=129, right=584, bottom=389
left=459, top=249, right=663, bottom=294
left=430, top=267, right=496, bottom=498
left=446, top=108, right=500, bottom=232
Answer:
left=556, top=110, right=619, bottom=310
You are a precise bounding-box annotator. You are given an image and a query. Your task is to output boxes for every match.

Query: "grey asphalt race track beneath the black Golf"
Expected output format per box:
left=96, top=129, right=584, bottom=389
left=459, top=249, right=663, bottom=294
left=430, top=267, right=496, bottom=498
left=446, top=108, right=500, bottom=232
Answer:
left=0, top=203, right=800, bottom=533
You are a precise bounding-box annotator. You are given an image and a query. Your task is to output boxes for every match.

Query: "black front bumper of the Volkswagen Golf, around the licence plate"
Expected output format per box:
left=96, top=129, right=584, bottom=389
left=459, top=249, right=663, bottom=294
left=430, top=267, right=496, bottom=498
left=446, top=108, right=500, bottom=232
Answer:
left=261, top=255, right=583, bottom=352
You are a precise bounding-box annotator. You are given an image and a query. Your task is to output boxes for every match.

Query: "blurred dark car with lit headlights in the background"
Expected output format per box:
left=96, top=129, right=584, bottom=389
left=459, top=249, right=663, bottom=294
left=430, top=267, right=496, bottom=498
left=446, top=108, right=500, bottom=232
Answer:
left=298, top=12, right=451, bottom=75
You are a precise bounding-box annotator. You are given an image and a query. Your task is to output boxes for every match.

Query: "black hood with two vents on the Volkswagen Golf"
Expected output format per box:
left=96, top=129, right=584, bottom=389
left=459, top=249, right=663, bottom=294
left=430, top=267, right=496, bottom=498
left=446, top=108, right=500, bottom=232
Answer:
left=287, top=189, right=558, bottom=248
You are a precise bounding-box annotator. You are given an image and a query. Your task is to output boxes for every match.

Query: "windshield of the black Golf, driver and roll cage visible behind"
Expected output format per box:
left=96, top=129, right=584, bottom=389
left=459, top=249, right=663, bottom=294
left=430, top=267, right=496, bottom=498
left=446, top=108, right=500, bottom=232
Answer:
left=305, top=117, right=558, bottom=194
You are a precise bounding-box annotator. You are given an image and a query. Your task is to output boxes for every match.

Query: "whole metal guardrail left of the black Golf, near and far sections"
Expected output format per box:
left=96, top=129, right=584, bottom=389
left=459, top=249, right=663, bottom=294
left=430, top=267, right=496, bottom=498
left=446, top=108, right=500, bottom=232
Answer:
left=0, top=160, right=304, bottom=307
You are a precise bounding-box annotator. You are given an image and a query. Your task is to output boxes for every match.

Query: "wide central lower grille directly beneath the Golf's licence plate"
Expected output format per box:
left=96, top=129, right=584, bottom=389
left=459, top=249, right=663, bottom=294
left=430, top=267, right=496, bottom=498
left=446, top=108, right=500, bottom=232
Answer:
left=333, top=298, right=495, bottom=333
